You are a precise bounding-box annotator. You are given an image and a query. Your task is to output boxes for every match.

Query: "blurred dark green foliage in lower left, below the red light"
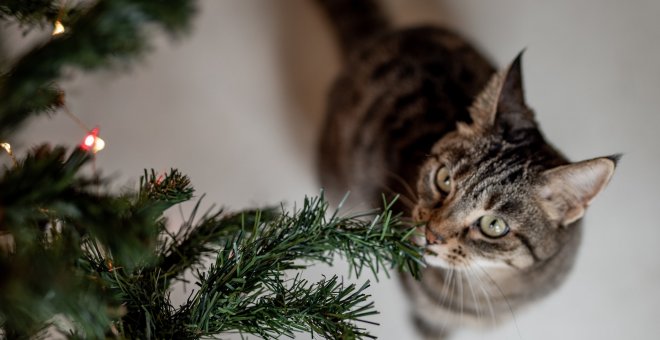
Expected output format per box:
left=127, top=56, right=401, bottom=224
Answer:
left=0, top=151, right=183, bottom=338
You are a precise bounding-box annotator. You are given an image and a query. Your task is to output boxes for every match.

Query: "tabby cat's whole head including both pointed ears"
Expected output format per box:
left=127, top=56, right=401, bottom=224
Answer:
left=413, top=52, right=616, bottom=269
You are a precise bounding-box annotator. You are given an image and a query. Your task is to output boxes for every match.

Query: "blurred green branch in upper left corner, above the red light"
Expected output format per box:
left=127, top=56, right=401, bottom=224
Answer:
left=0, top=0, right=194, bottom=139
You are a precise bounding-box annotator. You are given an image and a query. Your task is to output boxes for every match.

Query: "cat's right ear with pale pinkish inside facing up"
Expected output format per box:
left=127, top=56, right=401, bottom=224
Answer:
left=537, top=155, right=620, bottom=226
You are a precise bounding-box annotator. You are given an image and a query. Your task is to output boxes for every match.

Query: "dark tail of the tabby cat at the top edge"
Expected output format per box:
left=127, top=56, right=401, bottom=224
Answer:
left=316, top=0, right=390, bottom=57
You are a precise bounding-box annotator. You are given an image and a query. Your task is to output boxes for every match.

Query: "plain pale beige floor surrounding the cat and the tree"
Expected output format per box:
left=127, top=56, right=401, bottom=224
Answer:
left=13, top=0, right=660, bottom=340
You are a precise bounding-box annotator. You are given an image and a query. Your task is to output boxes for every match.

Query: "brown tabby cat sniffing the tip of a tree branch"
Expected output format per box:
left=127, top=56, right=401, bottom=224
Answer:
left=317, top=0, right=619, bottom=339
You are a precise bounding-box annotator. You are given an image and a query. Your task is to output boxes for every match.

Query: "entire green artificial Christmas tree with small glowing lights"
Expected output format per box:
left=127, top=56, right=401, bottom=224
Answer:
left=0, top=0, right=420, bottom=339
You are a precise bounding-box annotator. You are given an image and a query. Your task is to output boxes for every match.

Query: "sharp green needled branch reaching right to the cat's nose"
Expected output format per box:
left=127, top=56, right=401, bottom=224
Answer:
left=77, top=193, right=421, bottom=339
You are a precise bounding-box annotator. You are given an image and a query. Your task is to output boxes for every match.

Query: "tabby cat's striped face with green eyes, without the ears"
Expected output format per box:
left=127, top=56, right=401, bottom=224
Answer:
left=413, top=133, right=561, bottom=269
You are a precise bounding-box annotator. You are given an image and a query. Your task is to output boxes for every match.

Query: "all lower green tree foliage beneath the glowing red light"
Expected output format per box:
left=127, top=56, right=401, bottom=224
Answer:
left=0, top=147, right=420, bottom=339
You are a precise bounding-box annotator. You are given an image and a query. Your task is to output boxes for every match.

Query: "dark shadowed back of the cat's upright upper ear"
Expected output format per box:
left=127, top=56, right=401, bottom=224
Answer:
left=494, top=50, right=536, bottom=135
